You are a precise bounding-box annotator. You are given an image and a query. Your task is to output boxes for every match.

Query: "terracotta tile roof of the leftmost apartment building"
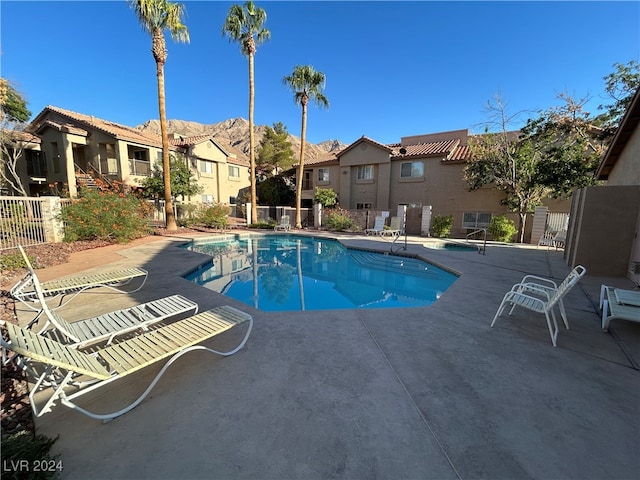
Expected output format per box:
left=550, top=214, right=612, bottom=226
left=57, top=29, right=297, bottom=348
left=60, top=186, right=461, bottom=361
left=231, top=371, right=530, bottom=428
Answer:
left=30, top=105, right=162, bottom=148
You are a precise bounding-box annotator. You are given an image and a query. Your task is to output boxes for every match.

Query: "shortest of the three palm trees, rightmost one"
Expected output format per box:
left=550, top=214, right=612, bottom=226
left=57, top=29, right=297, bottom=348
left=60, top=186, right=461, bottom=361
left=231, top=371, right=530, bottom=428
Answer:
left=282, top=65, right=329, bottom=228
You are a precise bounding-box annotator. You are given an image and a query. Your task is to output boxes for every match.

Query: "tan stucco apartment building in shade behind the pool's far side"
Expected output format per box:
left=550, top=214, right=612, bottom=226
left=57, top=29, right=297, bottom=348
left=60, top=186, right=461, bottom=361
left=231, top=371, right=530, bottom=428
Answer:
left=302, top=130, right=570, bottom=241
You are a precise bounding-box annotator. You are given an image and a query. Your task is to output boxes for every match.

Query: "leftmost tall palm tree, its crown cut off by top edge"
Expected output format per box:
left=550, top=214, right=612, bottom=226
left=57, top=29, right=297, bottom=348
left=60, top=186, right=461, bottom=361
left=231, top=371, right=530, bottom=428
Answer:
left=128, top=0, right=189, bottom=230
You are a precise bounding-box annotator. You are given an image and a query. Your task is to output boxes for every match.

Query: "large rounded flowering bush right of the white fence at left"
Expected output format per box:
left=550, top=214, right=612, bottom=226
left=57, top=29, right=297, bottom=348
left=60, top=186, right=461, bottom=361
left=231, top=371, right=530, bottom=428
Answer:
left=60, top=190, right=151, bottom=243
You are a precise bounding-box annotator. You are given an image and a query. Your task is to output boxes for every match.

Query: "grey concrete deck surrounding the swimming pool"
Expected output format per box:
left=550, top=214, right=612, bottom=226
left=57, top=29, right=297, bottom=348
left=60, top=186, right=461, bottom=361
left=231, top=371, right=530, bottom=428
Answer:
left=11, top=232, right=640, bottom=479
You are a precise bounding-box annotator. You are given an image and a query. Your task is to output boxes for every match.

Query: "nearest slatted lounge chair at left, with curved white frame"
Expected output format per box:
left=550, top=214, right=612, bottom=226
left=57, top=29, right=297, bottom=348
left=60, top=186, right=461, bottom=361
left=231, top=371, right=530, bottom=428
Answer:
left=0, top=306, right=253, bottom=421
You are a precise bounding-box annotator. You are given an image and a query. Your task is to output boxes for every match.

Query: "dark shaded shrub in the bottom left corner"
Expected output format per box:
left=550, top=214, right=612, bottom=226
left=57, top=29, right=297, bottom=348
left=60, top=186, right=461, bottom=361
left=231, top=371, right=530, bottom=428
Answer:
left=2, top=430, right=63, bottom=480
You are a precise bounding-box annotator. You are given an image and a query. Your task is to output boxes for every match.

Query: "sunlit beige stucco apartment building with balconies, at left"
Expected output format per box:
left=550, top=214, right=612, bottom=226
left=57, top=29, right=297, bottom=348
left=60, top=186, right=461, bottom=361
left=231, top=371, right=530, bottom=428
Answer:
left=11, top=106, right=249, bottom=203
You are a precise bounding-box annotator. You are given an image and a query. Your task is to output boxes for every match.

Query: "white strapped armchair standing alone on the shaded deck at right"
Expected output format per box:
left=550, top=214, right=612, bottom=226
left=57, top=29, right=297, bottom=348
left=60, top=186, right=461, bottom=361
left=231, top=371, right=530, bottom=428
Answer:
left=491, top=264, right=582, bottom=347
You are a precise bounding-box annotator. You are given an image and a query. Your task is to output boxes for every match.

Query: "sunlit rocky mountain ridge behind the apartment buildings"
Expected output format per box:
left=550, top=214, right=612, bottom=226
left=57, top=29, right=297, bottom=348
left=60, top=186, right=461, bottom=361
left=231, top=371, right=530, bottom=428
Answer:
left=136, top=118, right=347, bottom=159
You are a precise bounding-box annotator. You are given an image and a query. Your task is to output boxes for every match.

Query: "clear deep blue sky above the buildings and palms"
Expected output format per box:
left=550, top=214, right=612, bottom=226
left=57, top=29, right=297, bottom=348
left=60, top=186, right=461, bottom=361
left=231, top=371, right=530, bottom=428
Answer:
left=0, top=0, right=640, bottom=144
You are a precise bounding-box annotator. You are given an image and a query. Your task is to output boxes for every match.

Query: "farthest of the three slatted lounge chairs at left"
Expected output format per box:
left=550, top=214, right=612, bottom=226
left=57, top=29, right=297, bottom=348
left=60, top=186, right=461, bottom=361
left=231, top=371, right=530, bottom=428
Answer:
left=9, top=246, right=148, bottom=311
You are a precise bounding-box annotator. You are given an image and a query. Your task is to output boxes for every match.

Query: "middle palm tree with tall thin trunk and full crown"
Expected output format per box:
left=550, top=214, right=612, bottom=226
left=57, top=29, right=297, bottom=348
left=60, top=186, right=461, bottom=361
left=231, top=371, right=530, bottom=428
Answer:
left=222, top=1, right=271, bottom=222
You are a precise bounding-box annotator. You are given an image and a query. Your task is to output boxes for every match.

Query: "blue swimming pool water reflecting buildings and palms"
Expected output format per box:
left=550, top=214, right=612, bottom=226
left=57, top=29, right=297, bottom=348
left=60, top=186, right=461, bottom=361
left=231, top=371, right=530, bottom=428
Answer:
left=186, top=235, right=458, bottom=311
